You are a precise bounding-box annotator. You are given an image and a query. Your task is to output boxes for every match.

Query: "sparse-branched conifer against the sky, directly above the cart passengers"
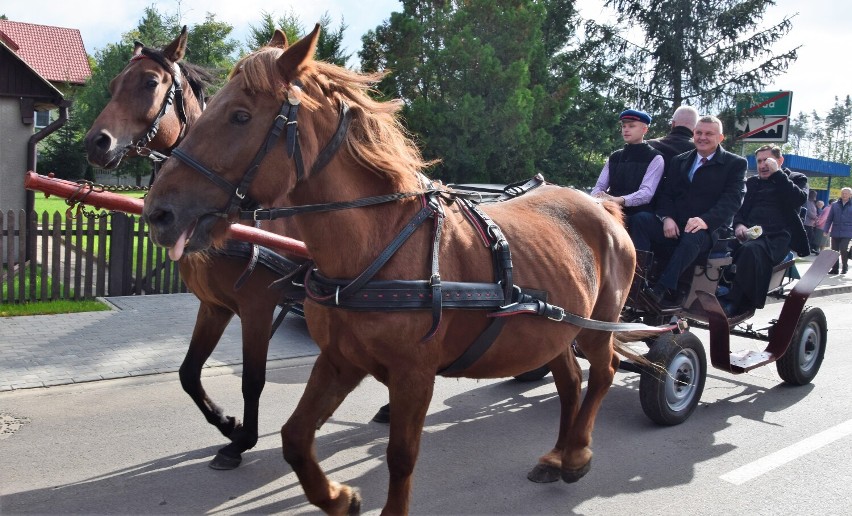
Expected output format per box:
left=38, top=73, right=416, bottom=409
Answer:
left=592, top=0, right=798, bottom=113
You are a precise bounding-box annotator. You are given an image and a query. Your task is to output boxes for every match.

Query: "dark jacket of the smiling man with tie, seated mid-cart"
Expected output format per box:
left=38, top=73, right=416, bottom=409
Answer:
left=656, top=145, right=748, bottom=233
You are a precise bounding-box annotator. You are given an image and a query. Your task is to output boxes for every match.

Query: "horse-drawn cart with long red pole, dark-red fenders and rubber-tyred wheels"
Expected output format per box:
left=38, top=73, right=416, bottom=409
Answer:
left=25, top=172, right=838, bottom=432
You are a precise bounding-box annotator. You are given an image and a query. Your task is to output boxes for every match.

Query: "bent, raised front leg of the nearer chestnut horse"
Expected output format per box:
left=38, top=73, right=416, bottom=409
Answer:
left=281, top=351, right=366, bottom=514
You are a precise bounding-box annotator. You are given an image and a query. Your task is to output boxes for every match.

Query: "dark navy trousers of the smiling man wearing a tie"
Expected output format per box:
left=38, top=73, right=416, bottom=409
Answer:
left=628, top=212, right=712, bottom=290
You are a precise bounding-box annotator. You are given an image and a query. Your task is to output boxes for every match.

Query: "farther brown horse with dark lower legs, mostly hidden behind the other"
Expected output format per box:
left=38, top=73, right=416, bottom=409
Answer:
left=85, top=27, right=304, bottom=469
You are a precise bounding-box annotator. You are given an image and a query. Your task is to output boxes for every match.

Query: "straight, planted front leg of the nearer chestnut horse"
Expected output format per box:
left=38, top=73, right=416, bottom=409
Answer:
left=382, top=371, right=435, bottom=514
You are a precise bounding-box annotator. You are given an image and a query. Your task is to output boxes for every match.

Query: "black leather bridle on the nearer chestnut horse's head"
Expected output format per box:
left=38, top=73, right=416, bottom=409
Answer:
left=172, top=83, right=352, bottom=221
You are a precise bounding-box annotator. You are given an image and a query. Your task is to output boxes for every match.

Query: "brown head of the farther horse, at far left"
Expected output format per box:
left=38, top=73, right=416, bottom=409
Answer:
left=85, top=26, right=212, bottom=169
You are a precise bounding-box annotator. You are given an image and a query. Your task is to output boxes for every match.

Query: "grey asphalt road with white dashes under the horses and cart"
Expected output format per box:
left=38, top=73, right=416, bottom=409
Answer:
left=0, top=294, right=852, bottom=515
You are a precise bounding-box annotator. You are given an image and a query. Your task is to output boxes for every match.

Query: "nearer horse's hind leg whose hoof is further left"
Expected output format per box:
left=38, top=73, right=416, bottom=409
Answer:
left=527, top=347, right=583, bottom=483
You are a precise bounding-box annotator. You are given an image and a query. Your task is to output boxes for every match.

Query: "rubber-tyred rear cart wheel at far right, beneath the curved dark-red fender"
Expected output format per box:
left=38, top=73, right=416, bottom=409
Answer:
left=775, top=307, right=827, bottom=385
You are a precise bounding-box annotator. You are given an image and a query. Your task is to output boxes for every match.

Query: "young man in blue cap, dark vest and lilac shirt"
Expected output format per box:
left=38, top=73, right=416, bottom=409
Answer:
left=591, top=109, right=665, bottom=228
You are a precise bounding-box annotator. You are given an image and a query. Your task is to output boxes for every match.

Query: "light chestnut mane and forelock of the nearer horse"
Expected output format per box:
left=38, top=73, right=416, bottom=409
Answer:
left=229, top=47, right=435, bottom=191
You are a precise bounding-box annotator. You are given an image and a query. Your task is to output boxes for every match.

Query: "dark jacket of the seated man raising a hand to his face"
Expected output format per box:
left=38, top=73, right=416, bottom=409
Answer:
left=734, top=168, right=811, bottom=256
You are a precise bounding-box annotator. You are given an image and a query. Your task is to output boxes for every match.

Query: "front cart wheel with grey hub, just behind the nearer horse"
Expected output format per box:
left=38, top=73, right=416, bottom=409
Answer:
left=639, top=332, right=707, bottom=425
